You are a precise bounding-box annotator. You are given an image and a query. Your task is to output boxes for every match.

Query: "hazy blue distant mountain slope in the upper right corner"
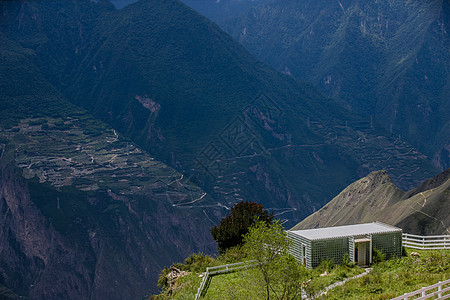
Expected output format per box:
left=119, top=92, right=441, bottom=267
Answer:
left=220, top=0, right=450, bottom=170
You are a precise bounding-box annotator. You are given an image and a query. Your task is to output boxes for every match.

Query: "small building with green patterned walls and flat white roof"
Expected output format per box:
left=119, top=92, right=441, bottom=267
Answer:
left=287, top=222, right=402, bottom=269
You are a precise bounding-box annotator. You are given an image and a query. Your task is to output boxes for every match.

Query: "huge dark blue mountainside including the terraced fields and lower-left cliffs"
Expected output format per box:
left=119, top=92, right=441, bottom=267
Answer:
left=0, top=0, right=438, bottom=299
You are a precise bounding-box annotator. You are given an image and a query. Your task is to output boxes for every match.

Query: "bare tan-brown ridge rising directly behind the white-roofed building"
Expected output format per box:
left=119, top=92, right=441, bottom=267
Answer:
left=293, top=169, right=450, bottom=235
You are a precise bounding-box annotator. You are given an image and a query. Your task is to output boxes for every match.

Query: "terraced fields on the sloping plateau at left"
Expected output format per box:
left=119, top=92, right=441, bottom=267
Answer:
left=0, top=117, right=204, bottom=205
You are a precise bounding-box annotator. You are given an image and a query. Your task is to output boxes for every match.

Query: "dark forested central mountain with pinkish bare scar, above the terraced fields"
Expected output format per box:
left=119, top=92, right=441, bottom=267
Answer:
left=67, top=1, right=437, bottom=219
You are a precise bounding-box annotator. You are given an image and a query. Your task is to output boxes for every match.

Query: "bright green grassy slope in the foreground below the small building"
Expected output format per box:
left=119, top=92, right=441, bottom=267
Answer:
left=157, top=250, right=450, bottom=299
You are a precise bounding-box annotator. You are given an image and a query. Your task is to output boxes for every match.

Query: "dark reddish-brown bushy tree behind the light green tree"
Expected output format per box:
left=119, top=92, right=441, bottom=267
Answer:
left=211, top=201, right=273, bottom=253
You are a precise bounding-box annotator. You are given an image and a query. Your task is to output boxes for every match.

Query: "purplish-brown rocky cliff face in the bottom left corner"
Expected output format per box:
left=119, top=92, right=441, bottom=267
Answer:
left=0, top=159, right=96, bottom=299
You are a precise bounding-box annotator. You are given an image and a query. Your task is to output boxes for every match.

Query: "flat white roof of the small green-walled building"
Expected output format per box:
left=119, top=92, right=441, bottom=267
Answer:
left=289, top=222, right=402, bottom=240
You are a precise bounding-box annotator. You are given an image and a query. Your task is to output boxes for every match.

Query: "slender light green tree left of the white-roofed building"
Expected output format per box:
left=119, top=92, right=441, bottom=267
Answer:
left=242, top=221, right=308, bottom=300
